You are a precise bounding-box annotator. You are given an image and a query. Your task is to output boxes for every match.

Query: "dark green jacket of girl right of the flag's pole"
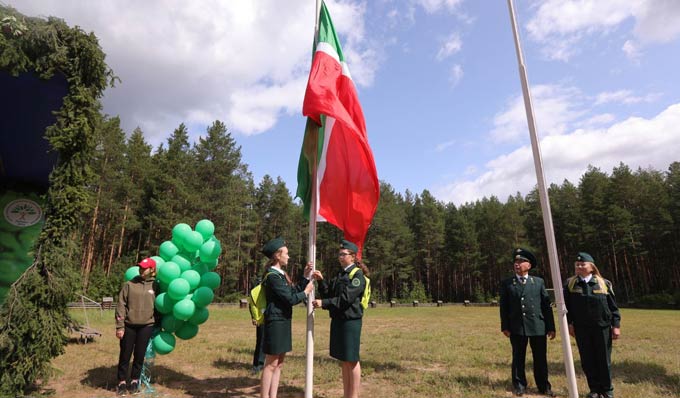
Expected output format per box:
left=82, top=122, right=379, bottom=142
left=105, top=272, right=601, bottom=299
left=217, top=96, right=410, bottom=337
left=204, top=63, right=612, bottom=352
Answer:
left=319, top=264, right=366, bottom=319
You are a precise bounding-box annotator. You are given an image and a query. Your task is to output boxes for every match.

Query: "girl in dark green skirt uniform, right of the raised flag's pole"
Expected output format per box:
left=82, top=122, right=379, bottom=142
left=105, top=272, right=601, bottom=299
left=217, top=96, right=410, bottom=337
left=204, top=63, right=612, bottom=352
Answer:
left=313, top=240, right=368, bottom=398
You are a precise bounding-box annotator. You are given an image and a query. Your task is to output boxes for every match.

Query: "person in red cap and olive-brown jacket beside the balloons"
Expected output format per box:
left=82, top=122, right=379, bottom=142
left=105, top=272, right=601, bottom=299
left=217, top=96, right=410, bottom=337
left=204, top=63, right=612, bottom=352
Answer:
left=116, top=258, right=158, bottom=395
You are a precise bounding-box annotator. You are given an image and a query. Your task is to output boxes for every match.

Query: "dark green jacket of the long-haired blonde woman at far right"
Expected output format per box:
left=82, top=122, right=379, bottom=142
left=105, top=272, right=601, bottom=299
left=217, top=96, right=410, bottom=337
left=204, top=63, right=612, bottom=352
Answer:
left=564, top=276, right=621, bottom=328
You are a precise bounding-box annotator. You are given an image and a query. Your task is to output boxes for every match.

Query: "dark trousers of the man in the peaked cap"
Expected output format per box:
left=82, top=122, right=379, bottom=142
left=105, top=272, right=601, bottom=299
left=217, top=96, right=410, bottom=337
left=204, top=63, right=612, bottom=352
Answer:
left=510, top=334, right=552, bottom=392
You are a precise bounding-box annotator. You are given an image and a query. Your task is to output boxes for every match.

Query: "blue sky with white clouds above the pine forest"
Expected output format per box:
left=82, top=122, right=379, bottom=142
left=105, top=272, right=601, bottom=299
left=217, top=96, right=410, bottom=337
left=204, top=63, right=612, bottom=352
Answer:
left=7, top=0, right=680, bottom=205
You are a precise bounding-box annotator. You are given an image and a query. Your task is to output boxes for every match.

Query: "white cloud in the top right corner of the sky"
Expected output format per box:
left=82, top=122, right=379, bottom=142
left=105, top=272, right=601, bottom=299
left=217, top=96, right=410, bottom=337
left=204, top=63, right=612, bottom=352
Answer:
left=526, top=0, right=680, bottom=61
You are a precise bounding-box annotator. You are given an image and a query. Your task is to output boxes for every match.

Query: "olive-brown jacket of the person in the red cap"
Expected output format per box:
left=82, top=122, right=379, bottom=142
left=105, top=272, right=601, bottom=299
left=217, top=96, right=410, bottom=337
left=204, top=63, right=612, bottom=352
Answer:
left=116, top=276, right=158, bottom=330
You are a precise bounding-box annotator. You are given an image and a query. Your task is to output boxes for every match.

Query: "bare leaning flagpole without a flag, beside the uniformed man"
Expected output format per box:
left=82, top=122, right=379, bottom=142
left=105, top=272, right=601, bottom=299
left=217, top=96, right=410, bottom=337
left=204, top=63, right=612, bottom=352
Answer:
left=508, top=0, right=578, bottom=398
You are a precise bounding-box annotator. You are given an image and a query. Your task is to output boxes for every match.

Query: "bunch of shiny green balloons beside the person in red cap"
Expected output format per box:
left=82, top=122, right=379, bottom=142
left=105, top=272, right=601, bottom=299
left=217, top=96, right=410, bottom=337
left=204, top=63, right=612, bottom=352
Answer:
left=125, top=220, right=222, bottom=355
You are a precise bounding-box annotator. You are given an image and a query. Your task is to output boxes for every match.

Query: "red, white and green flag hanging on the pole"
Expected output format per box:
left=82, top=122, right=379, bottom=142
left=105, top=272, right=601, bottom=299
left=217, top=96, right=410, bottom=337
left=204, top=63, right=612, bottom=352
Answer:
left=296, top=2, right=380, bottom=255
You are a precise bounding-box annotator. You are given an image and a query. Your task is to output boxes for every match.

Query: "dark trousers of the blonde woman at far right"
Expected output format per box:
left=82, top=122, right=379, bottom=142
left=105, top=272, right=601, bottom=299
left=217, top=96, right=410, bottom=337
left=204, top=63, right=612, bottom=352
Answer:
left=574, top=327, right=614, bottom=396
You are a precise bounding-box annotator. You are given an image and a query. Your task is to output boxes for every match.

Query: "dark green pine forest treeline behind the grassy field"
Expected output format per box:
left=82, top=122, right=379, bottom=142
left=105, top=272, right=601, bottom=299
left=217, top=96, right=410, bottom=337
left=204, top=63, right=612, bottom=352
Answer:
left=73, top=117, right=680, bottom=302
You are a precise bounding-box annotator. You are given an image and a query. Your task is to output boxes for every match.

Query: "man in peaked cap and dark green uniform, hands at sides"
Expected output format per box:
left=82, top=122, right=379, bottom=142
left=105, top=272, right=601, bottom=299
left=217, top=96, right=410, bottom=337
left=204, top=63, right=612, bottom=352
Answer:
left=499, top=248, right=555, bottom=397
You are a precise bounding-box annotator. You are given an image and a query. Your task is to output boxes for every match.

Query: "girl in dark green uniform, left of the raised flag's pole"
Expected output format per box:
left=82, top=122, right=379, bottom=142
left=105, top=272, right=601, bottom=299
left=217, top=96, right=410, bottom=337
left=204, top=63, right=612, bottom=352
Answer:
left=260, top=238, right=314, bottom=398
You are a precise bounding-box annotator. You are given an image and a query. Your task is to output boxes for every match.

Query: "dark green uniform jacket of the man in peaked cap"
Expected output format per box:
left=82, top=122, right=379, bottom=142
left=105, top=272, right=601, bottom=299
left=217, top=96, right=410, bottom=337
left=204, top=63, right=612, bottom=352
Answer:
left=499, top=275, right=555, bottom=336
